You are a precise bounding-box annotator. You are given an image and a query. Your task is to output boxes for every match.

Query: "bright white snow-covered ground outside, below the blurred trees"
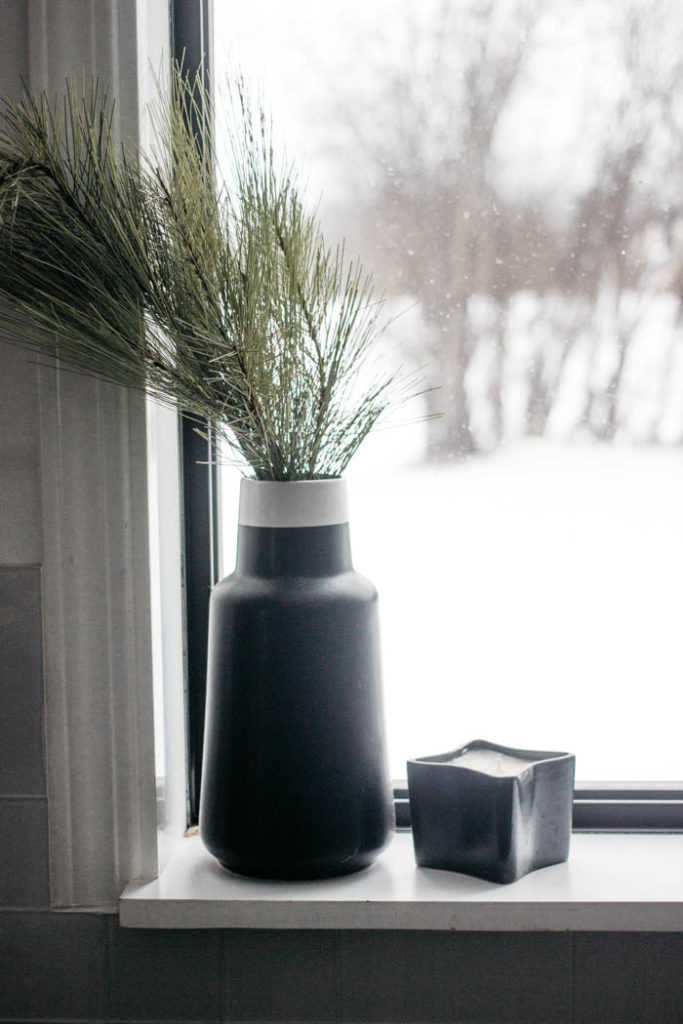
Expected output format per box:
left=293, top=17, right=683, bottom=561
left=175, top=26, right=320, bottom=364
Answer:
left=219, top=431, right=683, bottom=780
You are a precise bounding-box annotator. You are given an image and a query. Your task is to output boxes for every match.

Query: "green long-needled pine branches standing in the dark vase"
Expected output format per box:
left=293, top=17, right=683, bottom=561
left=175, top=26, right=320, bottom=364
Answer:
left=0, top=71, right=400, bottom=480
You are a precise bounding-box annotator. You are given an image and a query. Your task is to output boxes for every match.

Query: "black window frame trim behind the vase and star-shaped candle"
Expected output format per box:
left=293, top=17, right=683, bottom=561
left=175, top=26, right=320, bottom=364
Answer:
left=171, top=0, right=683, bottom=831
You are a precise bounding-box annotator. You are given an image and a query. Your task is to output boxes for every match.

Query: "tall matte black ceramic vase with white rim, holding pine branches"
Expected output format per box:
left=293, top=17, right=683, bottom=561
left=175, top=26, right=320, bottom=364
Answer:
left=200, top=479, right=393, bottom=879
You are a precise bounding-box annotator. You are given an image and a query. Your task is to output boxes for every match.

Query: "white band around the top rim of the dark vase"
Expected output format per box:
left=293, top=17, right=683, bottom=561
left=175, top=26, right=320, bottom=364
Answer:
left=239, top=478, right=348, bottom=528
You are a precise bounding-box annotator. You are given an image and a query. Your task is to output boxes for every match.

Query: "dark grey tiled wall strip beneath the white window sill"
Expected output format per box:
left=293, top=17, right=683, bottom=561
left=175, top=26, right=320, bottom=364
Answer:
left=0, top=910, right=683, bottom=1024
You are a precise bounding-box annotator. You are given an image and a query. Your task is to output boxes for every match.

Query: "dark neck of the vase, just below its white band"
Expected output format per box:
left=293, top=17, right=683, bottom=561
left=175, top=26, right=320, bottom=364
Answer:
left=236, top=523, right=353, bottom=577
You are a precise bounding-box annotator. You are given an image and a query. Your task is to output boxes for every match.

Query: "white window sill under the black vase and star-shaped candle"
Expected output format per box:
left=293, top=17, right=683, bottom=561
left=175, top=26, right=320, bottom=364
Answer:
left=120, top=833, right=683, bottom=932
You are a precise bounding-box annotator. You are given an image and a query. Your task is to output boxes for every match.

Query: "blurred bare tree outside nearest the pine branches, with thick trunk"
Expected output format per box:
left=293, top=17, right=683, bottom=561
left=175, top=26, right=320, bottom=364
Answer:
left=325, top=0, right=533, bottom=459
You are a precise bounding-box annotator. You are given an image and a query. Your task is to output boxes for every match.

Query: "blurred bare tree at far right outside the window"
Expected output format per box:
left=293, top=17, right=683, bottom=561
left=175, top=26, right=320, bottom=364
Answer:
left=577, top=0, right=683, bottom=440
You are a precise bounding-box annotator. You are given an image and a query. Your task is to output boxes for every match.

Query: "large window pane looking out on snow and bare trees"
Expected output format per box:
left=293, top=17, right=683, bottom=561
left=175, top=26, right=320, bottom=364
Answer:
left=214, top=0, right=683, bottom=780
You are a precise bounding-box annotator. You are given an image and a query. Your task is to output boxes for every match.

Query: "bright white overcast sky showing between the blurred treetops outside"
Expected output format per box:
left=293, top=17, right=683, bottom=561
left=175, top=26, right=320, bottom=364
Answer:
left=215, top=0, right=681, bottom=207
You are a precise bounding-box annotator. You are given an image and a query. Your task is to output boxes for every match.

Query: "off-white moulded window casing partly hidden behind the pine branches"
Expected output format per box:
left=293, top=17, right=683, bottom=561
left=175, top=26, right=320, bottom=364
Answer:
left=0, top=0, right=170, bottom=910
